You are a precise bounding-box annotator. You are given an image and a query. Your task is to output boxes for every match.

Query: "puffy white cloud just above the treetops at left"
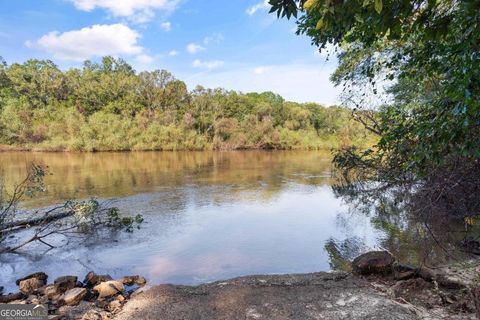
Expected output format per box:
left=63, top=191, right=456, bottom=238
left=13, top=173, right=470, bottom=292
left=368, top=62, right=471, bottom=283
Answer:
left=37, top=24, right=145, bottom=61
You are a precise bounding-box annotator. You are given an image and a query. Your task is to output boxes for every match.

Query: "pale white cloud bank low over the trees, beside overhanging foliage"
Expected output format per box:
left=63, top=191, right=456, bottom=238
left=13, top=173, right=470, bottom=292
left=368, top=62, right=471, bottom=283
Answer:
left=183, top=63, right=341, bottom=105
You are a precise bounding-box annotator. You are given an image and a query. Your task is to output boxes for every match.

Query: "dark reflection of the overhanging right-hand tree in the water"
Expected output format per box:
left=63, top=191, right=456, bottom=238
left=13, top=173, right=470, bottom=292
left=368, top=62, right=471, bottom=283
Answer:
left=327, top=182, right=473, bottom=265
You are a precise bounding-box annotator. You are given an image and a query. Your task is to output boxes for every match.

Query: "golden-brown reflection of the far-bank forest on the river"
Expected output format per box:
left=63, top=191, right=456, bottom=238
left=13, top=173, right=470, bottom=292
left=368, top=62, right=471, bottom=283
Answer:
left=0, top=151, right=331, bottom=206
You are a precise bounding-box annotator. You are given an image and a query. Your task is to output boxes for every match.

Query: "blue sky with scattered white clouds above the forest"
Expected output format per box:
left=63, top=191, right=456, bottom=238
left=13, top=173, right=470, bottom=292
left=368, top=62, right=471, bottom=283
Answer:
left=0, top=0, right=339, bottom=104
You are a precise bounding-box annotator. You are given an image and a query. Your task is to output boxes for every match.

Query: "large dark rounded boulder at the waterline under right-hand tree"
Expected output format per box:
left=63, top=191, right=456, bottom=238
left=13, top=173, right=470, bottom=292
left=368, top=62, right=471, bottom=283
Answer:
left=352, top=251, right=395, bottom=275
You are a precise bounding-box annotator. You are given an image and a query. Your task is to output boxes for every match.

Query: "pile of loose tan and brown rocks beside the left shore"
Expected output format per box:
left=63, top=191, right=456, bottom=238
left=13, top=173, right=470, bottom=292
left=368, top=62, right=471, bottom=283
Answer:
left=0, top=271, right=147, bottom=320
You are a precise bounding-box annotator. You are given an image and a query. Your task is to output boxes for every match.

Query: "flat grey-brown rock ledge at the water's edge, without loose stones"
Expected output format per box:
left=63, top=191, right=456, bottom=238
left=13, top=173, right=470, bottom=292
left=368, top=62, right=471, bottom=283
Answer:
left=115, top=272, right=416, bottom=320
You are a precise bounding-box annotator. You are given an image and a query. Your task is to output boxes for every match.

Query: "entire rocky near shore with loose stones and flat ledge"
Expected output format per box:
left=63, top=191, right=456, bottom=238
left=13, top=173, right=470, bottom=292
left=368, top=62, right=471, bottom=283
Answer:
left=0, top=251, right=480, bottom=320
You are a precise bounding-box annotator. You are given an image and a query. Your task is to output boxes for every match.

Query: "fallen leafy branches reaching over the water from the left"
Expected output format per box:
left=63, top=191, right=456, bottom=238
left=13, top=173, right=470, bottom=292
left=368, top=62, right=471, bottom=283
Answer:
left=0, top=165, right=144, bottom=253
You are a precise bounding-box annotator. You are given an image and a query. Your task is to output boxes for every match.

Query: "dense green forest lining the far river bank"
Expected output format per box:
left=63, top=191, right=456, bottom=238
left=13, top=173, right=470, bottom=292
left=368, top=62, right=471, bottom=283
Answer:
left=0, top=57, right=373, bottom=151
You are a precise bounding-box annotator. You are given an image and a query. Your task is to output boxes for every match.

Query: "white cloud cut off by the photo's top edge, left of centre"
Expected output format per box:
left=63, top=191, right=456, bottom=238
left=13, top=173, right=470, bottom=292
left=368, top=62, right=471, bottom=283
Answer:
left=70, top=0, right=180, bottom=23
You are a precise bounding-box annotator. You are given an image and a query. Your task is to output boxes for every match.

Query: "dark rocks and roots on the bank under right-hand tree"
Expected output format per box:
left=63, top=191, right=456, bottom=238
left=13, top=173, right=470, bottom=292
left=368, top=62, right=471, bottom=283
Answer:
left=352, top=251, right=480, bottom=317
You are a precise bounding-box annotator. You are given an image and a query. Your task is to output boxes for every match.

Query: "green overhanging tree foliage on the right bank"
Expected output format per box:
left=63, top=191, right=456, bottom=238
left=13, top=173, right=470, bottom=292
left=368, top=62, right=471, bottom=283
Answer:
left=270, top=0, right=480, bottom=180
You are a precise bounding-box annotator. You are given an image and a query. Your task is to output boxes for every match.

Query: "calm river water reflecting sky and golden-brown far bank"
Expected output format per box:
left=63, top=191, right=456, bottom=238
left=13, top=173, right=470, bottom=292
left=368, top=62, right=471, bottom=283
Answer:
left=0, top=151, right=382, bottom=287
